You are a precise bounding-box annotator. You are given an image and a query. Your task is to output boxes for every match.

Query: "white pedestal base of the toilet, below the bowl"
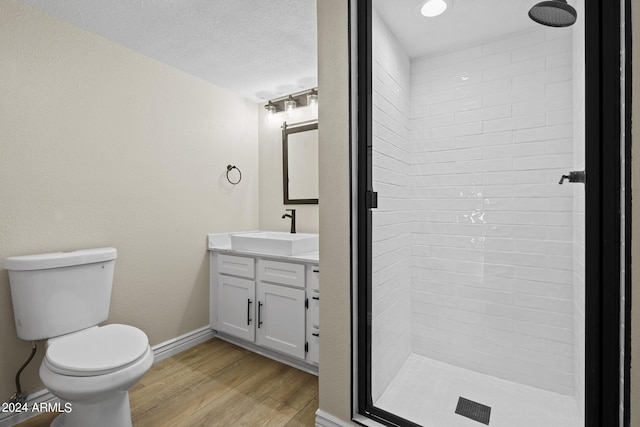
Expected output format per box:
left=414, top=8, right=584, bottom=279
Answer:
left=51, top=391, right=132, bottom=427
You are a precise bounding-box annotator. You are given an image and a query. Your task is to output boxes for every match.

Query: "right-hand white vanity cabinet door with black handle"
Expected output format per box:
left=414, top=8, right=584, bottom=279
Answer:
left=256, top=282, right=305, bottom=359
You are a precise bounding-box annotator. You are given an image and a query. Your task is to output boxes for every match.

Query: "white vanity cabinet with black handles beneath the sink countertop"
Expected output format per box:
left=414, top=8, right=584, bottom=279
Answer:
left=211, top=252, right=320, bottom=369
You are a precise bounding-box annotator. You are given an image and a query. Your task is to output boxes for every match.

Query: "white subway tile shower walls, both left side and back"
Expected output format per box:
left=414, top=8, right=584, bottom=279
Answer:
left=372, top=8, right=584, bottom=409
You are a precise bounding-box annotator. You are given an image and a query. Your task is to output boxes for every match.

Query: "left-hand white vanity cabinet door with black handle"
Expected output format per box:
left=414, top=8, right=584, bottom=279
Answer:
left=218, top=274, right=256, bottom=341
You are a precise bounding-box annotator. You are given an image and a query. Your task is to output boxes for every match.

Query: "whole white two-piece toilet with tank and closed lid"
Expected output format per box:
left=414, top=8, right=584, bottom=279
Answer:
left=3, top=248, right=153, bottom=427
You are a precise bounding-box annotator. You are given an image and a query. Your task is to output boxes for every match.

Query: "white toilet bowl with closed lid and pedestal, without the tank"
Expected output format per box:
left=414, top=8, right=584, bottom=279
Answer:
left=40, top=324, right=153, bottom=427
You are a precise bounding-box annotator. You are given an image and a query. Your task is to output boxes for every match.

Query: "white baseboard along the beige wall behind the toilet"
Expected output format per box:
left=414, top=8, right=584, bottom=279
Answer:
left=0, top=326, right=215, bottom=427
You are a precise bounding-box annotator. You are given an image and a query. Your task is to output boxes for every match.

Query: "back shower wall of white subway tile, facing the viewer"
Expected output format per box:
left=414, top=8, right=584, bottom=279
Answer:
left=411, top=28, right=574, bottom=394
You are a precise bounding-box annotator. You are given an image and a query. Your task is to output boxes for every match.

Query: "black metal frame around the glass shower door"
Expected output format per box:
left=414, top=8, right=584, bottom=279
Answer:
left=351, top=0, right=631, bottom=427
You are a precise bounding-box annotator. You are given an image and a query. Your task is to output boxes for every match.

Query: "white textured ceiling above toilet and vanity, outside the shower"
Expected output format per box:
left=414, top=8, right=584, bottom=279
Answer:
left=20, top=0, right=317, bottom=102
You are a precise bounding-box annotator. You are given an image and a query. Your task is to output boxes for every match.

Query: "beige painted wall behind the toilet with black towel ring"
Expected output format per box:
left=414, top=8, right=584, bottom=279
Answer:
left=0, top=0, right=258, bottom=397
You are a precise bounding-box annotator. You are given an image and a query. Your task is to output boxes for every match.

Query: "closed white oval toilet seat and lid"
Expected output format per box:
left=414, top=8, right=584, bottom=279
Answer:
left=44, top=324, right=149, bottom=377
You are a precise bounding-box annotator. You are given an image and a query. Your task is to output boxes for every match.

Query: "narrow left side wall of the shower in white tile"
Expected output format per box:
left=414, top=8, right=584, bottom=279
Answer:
left=371, top=13, right=414, bottom=402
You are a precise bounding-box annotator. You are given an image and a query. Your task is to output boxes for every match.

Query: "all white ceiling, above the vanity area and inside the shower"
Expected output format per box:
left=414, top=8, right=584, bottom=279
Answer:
left=12, top=0, right=556, bottom=102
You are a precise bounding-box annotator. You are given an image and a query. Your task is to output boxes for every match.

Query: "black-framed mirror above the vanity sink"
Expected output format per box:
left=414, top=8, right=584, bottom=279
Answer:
left=282, top=122, right=318, bottom=205
